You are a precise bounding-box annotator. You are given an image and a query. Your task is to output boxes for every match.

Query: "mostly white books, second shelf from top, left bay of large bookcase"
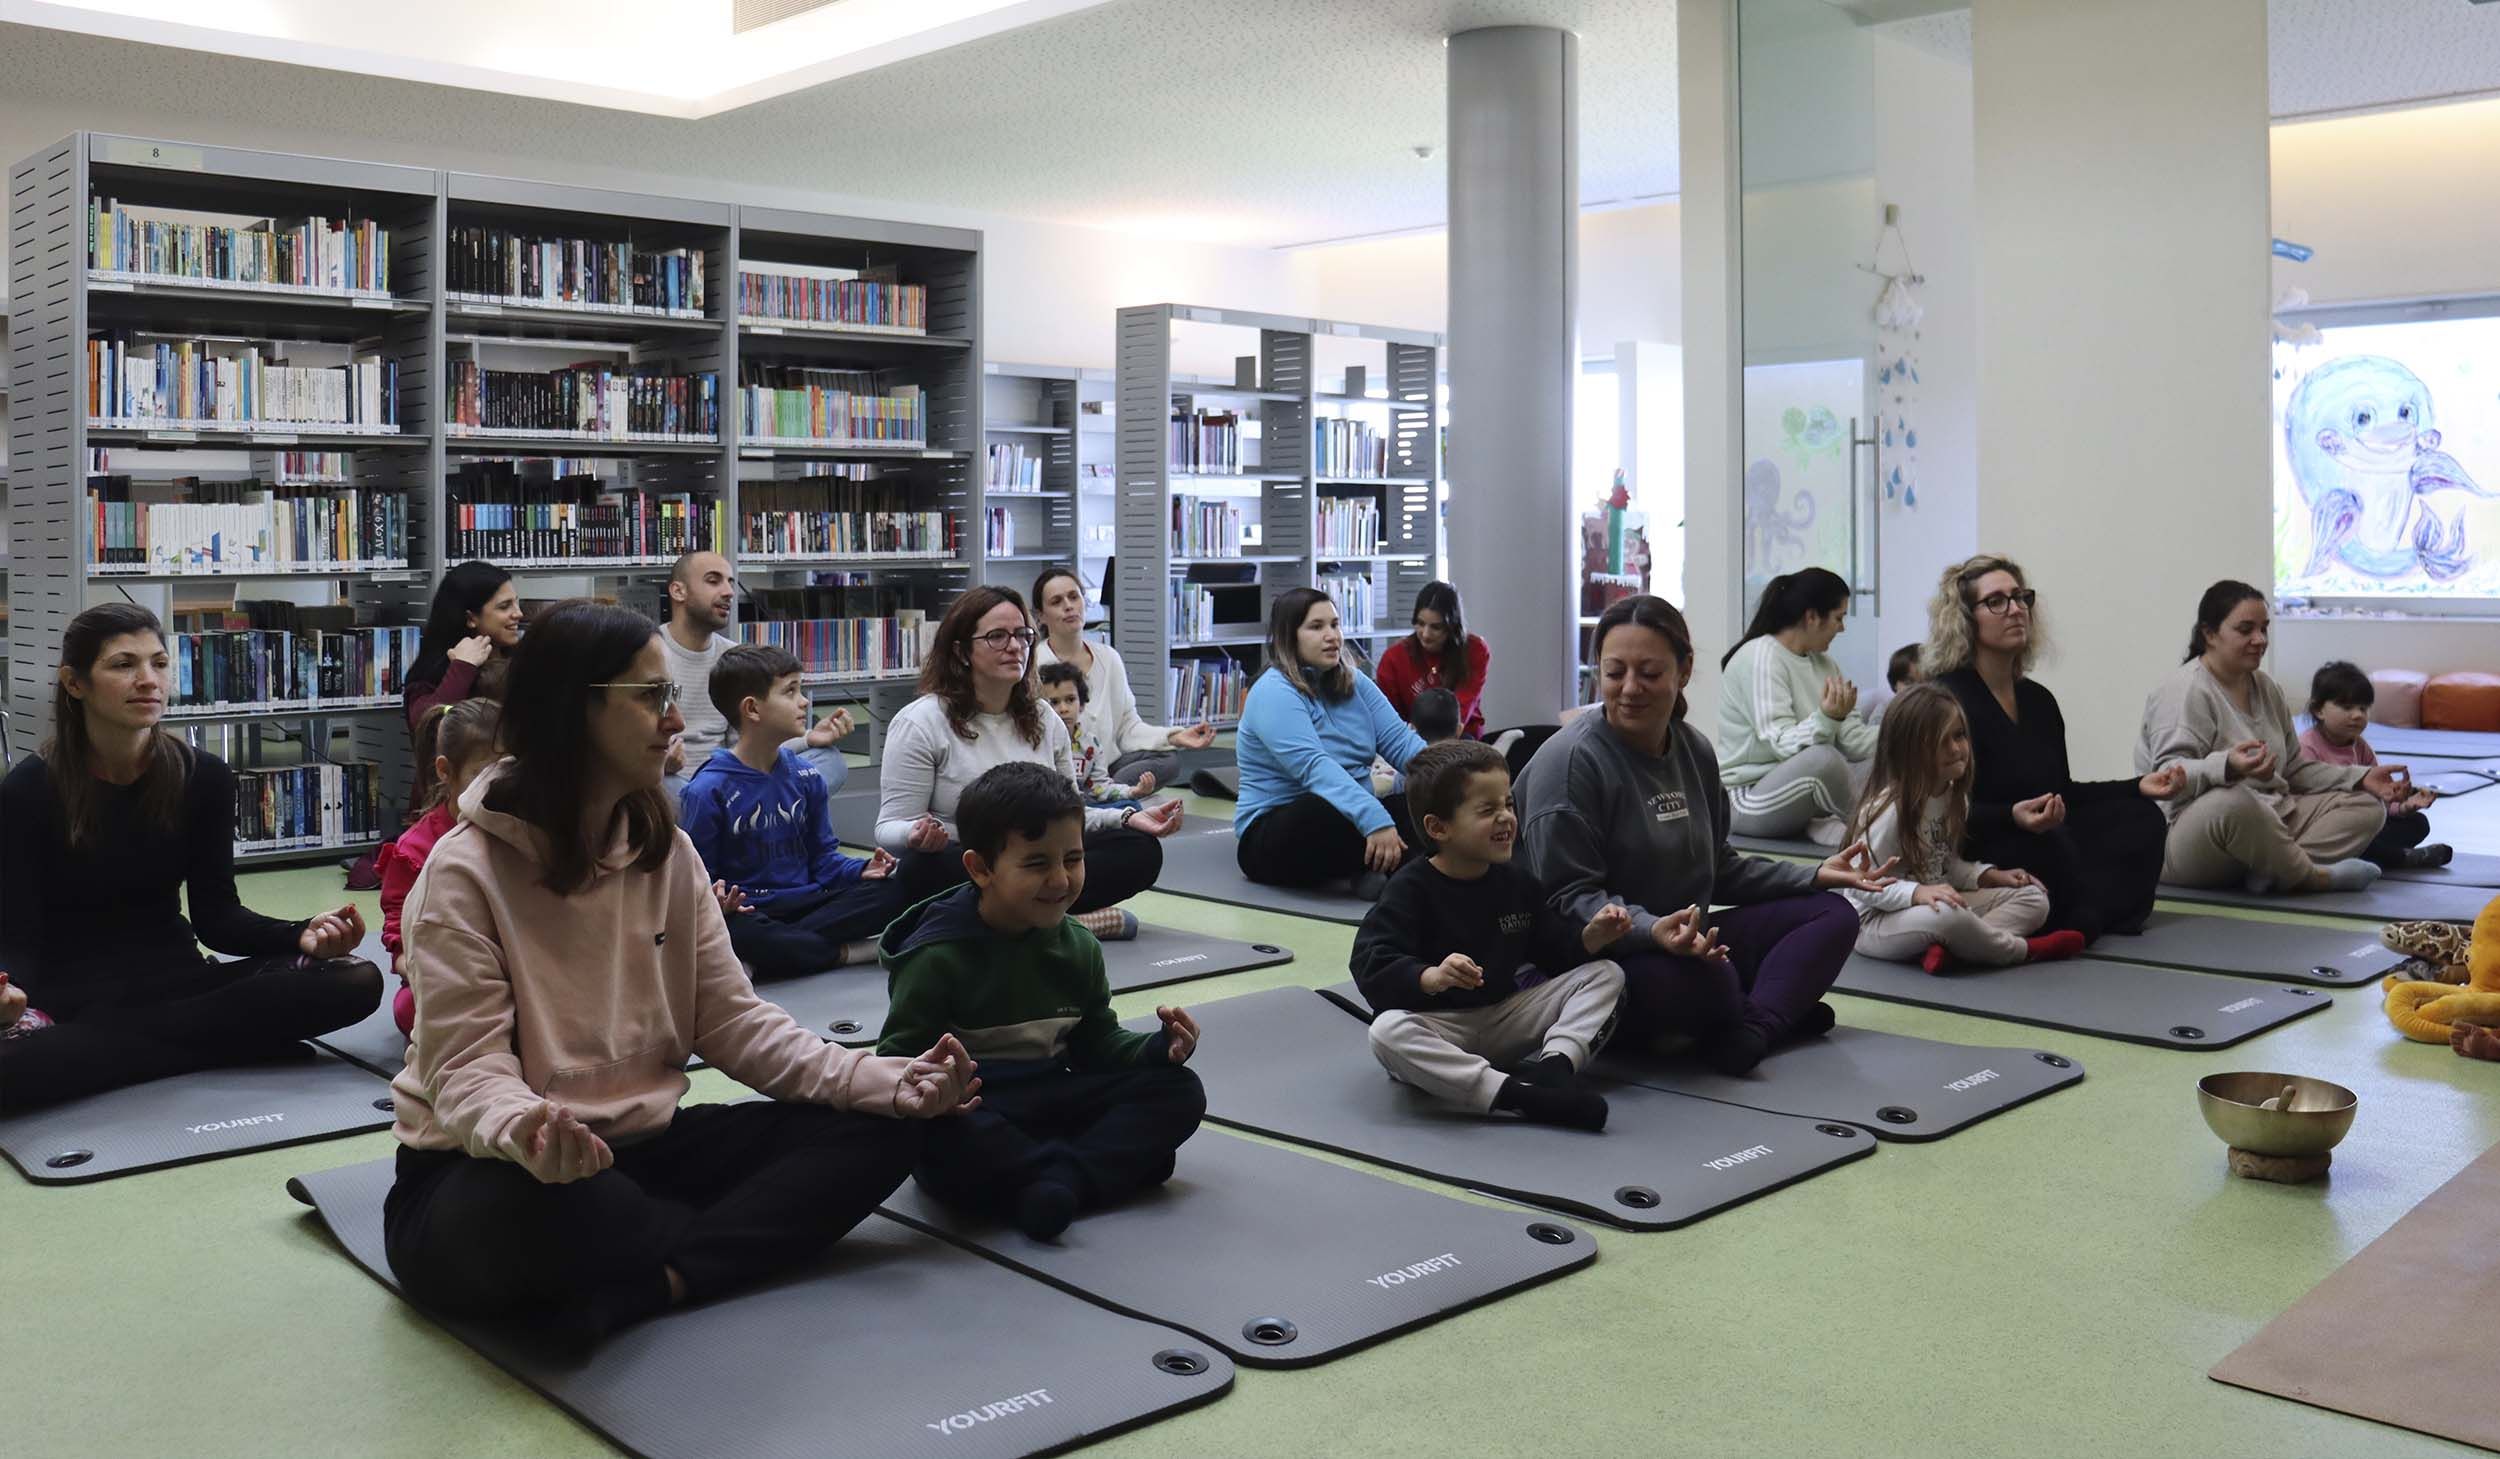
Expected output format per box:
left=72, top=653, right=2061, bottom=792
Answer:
left=88, top=335, right=400, bottom=432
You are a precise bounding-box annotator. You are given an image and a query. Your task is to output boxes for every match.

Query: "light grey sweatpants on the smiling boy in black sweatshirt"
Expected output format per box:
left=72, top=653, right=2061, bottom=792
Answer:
left=1373, top=957, right=1623, bottom=1114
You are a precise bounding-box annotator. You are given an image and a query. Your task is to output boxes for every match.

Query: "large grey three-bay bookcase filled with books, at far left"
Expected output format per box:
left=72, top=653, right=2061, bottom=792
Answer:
left=0, top=132, right=983, bottom=859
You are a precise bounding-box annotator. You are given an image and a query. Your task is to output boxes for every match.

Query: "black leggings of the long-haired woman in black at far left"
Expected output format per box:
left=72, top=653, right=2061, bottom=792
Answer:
left=0, top=952, right=383, bottom=1112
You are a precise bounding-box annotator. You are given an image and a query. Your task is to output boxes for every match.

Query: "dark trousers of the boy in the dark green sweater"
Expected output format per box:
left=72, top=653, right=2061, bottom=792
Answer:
left=920, top=1064, right=1208, bottom=1214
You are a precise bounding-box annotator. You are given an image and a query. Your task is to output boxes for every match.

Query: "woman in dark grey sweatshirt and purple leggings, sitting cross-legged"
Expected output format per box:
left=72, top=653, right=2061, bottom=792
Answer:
left=1518, top=595, right=1890, bottom=1074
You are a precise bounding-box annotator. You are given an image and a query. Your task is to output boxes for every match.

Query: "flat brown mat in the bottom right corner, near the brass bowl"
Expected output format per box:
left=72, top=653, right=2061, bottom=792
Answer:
left=2213, top=1134, right=2500, bottom=1449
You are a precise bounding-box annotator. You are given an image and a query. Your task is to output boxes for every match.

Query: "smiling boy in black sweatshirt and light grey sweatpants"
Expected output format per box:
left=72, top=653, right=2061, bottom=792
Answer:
left=1355, top=739, right=1633, bottom=1129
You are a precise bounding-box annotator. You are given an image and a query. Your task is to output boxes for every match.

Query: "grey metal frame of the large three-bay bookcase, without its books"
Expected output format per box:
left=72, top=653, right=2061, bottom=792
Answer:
left=0, top=132, right=983, bottom=854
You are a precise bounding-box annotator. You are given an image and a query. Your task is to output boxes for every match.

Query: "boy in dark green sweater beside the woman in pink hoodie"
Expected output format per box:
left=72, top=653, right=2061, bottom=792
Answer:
left=878, top=762, right=1208, bottom=1242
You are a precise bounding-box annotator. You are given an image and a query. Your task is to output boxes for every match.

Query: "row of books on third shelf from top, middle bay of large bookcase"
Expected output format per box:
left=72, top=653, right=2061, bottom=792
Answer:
left=443, top=462, right=728, bottom=565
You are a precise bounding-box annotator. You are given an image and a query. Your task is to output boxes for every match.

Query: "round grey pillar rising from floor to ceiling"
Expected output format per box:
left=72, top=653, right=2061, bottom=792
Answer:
left=1450, top=25, right=1580, bottom=727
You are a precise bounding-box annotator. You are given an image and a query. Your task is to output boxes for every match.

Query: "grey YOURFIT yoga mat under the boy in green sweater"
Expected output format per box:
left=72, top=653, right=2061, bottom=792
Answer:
left=885, top=1129, right=1598, bottom=1367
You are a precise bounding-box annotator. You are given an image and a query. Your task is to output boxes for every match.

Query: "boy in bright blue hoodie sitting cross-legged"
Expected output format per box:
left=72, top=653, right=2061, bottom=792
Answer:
left=680, top=645, right=905, bottom=982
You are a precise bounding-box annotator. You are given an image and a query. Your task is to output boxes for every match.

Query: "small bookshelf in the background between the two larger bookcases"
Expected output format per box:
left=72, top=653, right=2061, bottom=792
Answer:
left=983, top=362, right=1115, bottom=622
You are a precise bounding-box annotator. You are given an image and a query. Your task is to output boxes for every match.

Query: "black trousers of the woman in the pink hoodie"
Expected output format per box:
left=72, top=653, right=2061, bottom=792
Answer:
left=383, top=1099, right=925, bottom=1329
